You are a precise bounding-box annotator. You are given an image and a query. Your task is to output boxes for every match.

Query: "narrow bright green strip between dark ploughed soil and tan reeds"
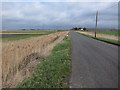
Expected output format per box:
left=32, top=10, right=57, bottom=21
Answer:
left=2, top=34, right=48, bottom=41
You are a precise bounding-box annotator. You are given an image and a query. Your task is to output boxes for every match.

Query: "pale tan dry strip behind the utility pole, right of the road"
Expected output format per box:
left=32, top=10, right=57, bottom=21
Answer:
left=77, top=31, right=119, bottom=40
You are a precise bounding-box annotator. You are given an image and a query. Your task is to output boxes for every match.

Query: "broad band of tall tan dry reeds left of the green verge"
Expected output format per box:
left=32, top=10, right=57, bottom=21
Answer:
left=2, top=32, right=68, bottom=88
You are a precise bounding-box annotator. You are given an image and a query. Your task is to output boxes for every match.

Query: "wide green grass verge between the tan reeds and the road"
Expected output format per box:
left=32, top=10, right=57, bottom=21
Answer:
left=18, top=32, right=71, bottom=88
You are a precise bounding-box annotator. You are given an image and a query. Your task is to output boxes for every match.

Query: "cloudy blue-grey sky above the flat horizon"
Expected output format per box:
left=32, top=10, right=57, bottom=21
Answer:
left=2, top=0, right=118, bottom=30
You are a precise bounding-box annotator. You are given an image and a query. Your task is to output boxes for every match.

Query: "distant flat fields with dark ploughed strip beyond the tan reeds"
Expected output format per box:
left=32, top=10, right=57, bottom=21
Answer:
left=0, top=30, right=62, bottom=42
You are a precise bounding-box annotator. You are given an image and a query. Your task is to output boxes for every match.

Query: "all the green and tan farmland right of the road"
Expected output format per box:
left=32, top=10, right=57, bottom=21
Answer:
left=77, top=31, right=120, bottom=45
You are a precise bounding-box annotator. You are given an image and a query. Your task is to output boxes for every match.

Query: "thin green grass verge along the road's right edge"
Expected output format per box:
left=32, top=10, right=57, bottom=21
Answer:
left=77, top=32, right=120, bottom=45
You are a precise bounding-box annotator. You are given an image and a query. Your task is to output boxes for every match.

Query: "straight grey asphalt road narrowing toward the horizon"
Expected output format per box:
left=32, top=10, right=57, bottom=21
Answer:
left=69, top=32, right=118, bottom=88
